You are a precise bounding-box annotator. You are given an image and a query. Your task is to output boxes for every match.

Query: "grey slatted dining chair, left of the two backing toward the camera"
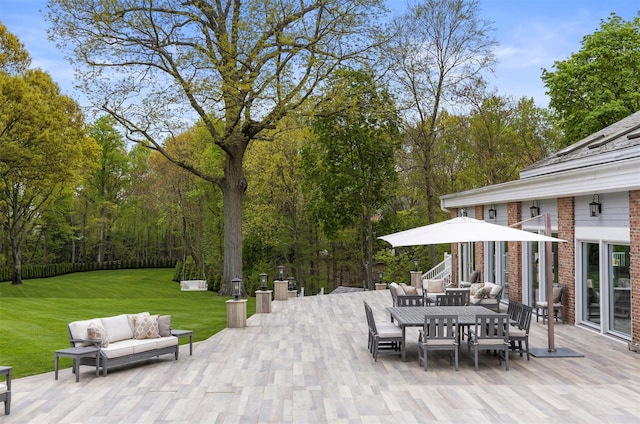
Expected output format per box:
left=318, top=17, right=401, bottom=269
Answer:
left=418, top=315, right=459, bottom=371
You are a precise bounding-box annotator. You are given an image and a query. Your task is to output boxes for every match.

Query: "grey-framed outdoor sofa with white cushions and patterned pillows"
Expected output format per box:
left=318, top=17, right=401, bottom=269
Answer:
left=68, top=312, right=179, bottom=376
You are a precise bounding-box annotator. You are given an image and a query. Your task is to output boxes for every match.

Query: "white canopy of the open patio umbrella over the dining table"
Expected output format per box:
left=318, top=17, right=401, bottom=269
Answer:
left=379, top=216, right=566, bottom=247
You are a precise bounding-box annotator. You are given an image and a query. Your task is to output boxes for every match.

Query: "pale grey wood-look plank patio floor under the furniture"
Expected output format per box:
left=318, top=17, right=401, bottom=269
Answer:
left=0, top=291, right=640, bottom=424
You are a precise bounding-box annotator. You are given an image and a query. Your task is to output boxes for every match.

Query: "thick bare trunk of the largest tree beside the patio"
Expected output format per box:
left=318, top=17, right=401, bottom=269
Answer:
left=219, top=154, right=247, bottom=296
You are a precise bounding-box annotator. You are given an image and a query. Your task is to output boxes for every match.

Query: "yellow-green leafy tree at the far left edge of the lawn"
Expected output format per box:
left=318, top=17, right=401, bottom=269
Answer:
left=0, top=23, right=94, bottom=284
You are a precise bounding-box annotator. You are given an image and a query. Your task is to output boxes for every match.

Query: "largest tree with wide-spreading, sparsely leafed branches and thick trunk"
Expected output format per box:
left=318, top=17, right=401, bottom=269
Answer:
left=49, top=0, right=383, bottom=294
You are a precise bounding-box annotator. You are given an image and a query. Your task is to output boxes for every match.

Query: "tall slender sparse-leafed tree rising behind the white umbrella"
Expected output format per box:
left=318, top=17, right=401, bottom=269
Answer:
left=387, top=0, right=496, bottom=264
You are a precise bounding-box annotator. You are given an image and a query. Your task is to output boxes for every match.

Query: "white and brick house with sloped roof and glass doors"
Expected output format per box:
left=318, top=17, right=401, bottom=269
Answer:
left=440, top=112, right=640, bottom=343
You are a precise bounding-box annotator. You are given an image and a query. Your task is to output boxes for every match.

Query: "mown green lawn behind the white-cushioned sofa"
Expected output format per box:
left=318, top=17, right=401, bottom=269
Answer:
left=0, top=269, right=255, bottom=378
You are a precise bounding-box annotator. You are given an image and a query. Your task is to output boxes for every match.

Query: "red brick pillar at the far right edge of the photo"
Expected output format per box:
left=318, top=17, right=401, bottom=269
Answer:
left=629, top=190, right=640, bottom=343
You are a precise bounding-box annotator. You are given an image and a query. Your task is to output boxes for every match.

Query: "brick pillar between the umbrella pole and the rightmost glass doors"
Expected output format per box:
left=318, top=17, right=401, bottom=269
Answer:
left=558, top=197, right=576, bottom=323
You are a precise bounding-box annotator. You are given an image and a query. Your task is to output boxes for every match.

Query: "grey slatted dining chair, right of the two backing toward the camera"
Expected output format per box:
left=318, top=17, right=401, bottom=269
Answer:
left=467, top=314, right=510, bottom=371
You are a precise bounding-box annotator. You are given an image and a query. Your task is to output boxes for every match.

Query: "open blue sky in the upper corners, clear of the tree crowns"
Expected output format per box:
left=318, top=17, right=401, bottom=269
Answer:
left=0, top=0, right=640, bottom=106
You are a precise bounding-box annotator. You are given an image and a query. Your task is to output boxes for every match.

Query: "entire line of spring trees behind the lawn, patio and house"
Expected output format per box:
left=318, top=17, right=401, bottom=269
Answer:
left=0, top=0, right=639, bottom=294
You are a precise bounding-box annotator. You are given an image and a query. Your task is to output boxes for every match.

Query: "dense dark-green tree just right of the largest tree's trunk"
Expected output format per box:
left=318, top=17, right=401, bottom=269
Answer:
left=302, top=70, right=400, bottom=289
